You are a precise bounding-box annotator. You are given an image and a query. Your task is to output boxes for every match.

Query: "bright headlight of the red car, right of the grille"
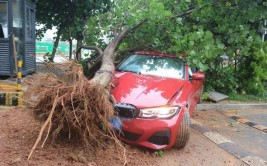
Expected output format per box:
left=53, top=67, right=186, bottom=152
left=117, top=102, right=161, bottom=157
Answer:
left=139, top=107, right=180, bottom=119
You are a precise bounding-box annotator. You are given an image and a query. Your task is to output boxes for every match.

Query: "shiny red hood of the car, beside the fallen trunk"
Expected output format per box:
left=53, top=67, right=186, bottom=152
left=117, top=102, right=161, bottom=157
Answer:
left=111, top=72, right=185, bottom=108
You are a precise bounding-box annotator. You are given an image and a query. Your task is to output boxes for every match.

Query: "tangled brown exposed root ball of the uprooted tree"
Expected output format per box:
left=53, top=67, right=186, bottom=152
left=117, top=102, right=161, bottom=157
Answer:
left=28, top=64, right=127, bottom=164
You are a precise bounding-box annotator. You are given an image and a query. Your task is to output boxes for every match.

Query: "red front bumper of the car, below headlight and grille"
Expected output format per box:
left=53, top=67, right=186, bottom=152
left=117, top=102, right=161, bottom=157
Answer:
left=113, top=109, right=184, bottom=149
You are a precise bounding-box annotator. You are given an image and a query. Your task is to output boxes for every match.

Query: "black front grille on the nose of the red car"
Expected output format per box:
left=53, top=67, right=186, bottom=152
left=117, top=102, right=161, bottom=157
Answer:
left=114, top=103, right=139, bottom=119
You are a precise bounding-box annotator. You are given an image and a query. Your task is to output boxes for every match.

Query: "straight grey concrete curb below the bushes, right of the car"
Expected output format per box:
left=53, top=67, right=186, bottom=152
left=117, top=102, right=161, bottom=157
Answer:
left=196, top=103, right=267, bottom=111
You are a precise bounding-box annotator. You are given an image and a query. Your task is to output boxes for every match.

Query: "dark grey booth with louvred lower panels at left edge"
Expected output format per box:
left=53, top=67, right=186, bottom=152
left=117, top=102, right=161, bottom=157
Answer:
left=0, top=0, right=37, bottom=76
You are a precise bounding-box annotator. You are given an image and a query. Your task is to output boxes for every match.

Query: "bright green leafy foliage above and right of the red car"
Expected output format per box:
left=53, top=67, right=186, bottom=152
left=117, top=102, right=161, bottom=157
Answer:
left=85, top=0, right=267, bottom=94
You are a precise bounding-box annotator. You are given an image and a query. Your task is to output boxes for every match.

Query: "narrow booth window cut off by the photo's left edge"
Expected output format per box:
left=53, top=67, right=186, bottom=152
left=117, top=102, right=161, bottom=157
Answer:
left=0, top=2, right=8, bottom=38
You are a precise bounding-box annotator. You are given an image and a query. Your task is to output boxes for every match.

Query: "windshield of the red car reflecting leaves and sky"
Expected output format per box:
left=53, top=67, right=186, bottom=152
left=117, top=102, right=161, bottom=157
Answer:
left=116, top=55, right=184, bottom=79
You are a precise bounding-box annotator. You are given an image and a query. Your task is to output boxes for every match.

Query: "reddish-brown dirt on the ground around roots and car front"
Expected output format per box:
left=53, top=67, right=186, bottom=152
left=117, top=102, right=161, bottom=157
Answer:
left=0, top=107, right=245, bottom=166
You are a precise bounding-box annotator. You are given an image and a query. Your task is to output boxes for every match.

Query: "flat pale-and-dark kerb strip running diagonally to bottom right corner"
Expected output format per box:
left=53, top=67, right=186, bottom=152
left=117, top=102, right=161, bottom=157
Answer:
left=191, top=119, right=267, bottom=166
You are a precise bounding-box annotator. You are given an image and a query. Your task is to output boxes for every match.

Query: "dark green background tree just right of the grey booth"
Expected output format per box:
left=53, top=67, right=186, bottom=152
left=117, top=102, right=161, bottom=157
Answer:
left=36, top=0, right=111, bottom=59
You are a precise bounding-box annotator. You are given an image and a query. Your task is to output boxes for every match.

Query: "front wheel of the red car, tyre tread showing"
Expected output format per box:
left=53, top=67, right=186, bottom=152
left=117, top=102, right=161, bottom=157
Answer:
left=174, top=109, right=190, bottom=149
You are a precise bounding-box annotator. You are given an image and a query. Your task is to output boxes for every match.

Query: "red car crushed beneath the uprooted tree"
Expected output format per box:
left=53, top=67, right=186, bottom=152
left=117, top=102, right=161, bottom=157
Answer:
left=111, top=51, right=205, bottom=149
